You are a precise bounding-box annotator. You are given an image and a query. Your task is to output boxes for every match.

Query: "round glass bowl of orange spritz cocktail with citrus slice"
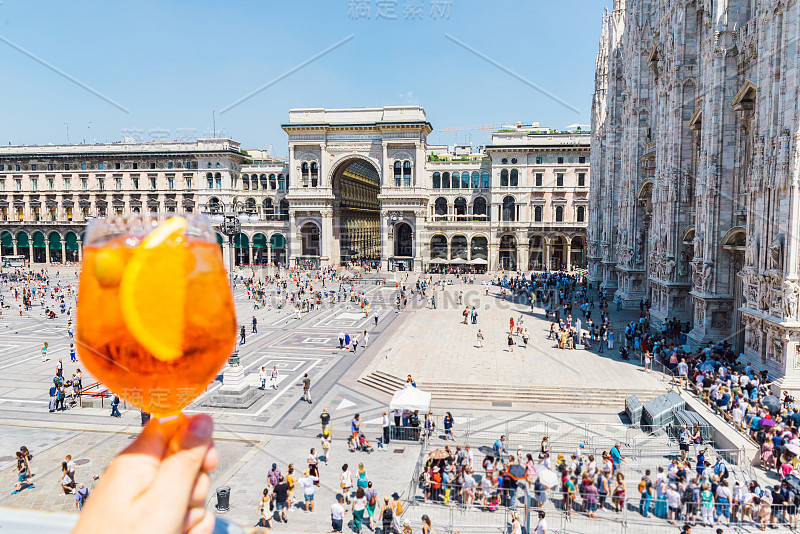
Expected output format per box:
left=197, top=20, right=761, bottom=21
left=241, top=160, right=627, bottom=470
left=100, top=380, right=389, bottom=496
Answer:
left=77, top=215, right=236, bottom=416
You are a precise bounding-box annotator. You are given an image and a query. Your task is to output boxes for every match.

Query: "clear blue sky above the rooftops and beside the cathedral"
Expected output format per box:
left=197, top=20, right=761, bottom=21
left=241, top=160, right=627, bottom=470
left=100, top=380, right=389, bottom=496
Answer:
left=0, top=0, right=611, bottom=156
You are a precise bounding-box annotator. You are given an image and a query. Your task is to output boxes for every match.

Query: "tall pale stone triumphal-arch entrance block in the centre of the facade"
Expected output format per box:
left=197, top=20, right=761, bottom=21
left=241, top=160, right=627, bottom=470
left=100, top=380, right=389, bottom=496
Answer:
left=282, top=106, right=431, bottom=270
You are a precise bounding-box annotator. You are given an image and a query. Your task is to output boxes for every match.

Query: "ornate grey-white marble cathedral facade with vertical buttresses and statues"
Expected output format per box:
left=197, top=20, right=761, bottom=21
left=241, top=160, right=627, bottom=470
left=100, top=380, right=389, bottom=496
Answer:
left=588, top=0, right=800, bottom=393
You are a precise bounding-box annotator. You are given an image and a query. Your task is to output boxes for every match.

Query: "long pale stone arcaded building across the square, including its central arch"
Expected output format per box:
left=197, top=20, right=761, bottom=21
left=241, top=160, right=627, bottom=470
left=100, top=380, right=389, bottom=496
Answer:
left=0, top=106, right=590, bottom=271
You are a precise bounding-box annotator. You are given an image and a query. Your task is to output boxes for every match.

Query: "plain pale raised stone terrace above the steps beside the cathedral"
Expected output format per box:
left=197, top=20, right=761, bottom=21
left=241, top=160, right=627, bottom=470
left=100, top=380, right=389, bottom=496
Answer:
left=363, top=283, right=665, bottom=404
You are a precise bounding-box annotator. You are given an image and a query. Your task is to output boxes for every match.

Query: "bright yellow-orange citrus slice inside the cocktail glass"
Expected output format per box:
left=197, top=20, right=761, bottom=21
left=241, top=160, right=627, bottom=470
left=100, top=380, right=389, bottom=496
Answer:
left=119, top=217, right=192, bottom=362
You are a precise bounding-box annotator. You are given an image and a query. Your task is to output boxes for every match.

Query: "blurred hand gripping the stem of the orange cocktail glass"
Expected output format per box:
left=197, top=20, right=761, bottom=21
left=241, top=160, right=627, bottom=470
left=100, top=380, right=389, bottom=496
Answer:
left=73, top=414, right=218, bottom=534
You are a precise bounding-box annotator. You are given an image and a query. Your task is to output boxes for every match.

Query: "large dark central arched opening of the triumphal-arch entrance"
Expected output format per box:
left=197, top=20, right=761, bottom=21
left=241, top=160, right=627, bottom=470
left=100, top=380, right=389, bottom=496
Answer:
left=331, top=157, right=381, bottom=264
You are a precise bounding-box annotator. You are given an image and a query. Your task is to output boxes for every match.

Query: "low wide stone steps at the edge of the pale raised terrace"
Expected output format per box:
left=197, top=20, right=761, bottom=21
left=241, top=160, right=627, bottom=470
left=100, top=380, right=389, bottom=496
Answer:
left=358, top=371, right=666, bottom=409
